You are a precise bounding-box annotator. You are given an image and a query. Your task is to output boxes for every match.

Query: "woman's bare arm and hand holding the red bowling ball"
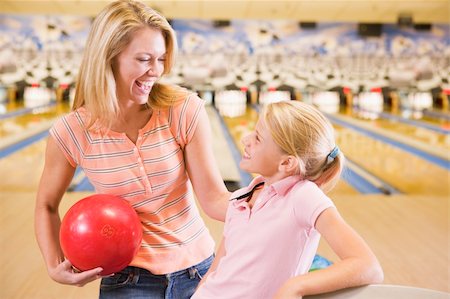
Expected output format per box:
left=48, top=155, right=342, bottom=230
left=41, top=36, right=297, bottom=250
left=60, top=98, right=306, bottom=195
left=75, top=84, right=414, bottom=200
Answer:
left=35, top=137, right=102, bottom=286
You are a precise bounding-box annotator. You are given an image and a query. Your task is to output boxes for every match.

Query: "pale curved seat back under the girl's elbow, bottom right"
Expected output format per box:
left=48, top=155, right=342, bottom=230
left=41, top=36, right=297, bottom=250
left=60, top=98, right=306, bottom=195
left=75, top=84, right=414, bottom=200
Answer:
left=304, top=284, right=450, bottom=299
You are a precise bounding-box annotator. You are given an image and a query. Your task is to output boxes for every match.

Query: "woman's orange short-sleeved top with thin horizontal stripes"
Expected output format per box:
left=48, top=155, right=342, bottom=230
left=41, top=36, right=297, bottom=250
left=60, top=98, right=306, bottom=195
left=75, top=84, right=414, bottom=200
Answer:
left=50, top=95, right=214, bottom=274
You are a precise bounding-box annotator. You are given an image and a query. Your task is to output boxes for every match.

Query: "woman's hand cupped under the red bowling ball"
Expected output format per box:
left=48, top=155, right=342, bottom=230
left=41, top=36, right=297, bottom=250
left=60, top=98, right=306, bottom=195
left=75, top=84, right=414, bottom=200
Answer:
left=49, top=259, right=103, bottom=287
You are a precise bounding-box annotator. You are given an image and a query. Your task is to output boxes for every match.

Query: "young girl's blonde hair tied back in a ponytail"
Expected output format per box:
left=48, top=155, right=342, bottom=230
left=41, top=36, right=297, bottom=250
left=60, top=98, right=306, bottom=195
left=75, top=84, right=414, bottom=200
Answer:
left=262, top=101, right=345, bottom=192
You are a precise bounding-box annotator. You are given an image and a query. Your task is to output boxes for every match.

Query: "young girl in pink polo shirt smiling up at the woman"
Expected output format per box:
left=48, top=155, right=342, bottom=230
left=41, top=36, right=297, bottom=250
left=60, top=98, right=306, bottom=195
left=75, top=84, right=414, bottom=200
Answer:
left=192, top=101, right=383, bottom=299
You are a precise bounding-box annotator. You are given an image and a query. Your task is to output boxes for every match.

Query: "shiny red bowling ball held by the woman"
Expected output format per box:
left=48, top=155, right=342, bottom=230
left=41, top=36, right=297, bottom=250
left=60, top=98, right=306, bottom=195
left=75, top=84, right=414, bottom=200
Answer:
left=59, top=194, right=142, bottom=275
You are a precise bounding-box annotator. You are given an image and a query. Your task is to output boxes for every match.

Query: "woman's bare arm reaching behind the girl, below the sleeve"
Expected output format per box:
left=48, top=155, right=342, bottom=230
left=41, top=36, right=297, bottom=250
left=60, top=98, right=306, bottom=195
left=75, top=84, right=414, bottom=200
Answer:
left=184, top=109, right=230, bottom=221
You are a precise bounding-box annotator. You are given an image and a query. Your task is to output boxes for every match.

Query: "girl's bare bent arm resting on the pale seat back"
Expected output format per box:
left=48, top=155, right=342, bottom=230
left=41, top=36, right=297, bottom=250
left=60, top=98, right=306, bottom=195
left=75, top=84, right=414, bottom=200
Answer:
left=275, top=208, right=383, bottom=299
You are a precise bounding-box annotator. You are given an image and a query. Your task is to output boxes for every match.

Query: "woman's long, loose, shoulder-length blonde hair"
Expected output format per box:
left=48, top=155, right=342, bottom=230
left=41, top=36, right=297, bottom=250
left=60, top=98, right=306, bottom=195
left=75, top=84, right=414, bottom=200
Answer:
left=72, top=0, right=188, bottom=127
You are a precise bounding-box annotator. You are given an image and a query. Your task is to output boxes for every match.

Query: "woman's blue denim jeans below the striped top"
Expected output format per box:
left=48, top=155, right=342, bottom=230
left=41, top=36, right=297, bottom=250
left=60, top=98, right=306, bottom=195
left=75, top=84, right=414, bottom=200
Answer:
left=100, top=256, right=214, bottom=299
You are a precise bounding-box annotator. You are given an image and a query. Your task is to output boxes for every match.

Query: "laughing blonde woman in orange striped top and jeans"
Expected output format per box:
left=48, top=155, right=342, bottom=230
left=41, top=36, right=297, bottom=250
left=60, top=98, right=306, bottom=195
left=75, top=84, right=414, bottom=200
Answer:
left=35, top=1, right=229, bottom=298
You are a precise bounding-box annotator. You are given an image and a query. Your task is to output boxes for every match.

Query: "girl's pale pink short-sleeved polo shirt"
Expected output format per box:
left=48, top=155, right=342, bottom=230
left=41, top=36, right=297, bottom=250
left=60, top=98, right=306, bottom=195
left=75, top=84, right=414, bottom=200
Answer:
left=192, top=176, right=334, bottom=299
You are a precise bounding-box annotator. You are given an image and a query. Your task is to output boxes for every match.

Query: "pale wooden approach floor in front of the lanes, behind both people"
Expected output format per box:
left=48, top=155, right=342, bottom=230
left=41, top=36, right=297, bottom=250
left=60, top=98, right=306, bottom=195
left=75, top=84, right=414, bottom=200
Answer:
left=0, top=192, right=450, bottom=299
